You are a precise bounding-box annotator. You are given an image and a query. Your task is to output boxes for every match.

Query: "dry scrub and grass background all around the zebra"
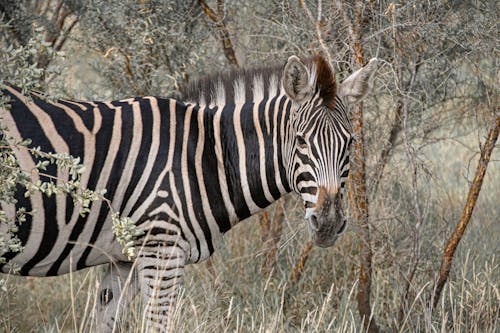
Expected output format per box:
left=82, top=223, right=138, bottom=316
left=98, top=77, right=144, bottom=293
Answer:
left=0, top=0, right=500, bottom=333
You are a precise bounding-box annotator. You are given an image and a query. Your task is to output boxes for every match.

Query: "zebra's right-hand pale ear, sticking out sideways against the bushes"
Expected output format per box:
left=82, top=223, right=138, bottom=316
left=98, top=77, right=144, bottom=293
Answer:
left=339, top=58, right=378, bottom=103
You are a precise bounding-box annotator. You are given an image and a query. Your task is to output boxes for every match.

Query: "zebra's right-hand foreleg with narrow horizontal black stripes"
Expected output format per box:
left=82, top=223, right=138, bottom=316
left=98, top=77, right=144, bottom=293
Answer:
left=137, top=242, right=186, bottom=332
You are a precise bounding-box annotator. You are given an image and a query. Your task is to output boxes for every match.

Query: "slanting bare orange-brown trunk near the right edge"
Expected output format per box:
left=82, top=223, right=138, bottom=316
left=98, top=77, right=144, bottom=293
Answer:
left=431, top=115, right=500, bottom=308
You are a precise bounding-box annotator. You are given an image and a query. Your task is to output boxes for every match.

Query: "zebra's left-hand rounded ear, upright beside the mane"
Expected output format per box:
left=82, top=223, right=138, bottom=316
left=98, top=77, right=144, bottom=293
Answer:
left=283, top=56, right=312, bottom=103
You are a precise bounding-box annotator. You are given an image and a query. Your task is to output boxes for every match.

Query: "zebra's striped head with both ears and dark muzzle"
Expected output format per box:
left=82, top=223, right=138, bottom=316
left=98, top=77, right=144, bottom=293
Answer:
left=282, top=56, right=377, bottom=247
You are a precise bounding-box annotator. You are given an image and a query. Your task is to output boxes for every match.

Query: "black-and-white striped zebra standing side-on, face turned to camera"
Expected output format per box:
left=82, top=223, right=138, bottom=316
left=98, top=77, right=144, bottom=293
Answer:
left=0, top=56, right=377, bottom=332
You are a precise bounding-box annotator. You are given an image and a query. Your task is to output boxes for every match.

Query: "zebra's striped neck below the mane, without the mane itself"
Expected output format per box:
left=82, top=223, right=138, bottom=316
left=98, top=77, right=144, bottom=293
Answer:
left=205, top=94, right=291, bottom=224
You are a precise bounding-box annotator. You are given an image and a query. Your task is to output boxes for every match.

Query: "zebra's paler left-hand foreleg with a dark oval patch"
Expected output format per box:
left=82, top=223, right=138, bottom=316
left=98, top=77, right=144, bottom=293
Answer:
left=96, top=262, right=139, bottom=332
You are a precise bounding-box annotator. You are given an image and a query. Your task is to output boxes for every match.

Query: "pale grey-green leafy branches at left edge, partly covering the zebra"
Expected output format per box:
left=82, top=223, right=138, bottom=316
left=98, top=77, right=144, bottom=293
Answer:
left=0, top=15, right=141, bottom=271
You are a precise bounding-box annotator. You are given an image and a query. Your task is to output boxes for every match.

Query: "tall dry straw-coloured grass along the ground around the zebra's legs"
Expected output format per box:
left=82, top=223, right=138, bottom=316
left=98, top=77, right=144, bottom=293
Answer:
left=0, top=193, right=500, bottom=333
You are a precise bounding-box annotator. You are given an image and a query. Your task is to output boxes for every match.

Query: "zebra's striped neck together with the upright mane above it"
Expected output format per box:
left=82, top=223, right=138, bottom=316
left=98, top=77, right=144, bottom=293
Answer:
left=183, top=66, right=293, bottom=224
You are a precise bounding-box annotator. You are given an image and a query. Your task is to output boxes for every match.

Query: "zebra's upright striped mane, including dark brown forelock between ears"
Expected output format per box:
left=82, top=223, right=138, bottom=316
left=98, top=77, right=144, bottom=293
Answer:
left=181, top=56, right=336, bottom=106
